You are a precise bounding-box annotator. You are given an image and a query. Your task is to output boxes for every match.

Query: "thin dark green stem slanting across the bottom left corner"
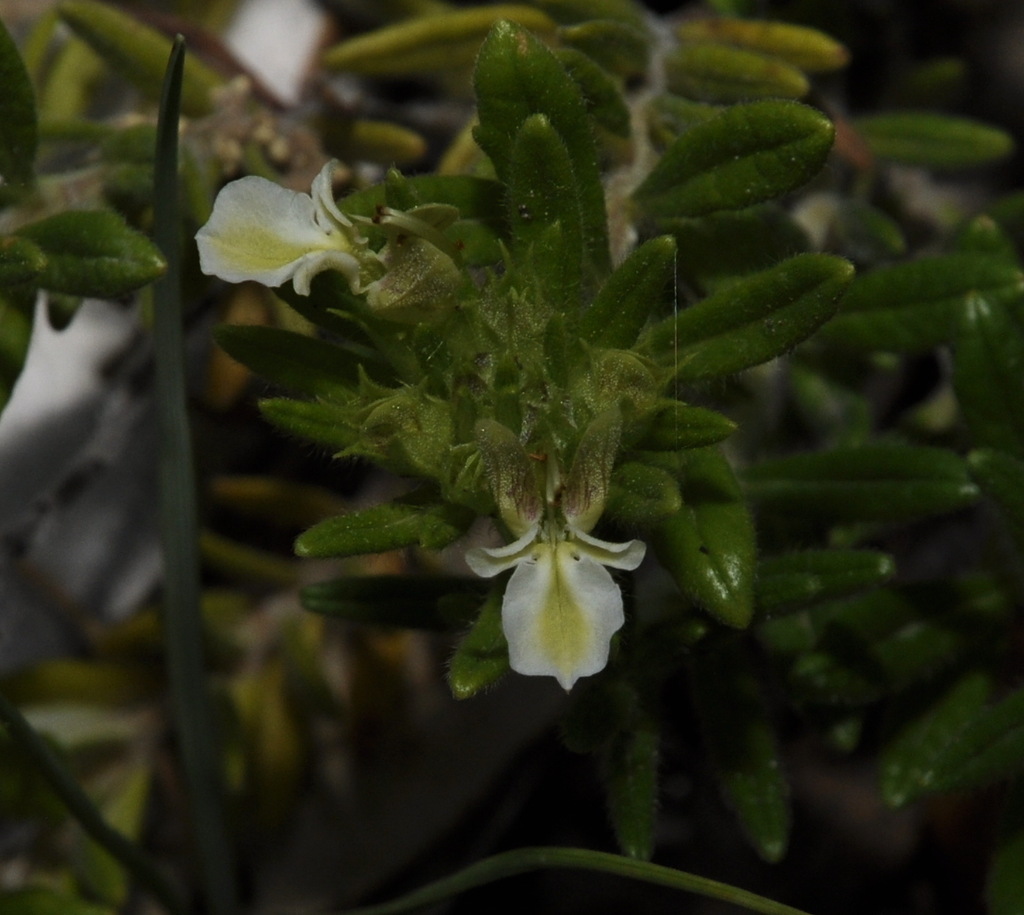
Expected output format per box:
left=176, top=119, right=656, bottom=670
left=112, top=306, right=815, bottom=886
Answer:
left=0, top=693, right=188, bottom=915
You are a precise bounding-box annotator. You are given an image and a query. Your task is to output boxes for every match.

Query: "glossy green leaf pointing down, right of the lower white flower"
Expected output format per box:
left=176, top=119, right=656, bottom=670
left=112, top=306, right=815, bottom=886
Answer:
left=651, top=448, right=757, bottom=628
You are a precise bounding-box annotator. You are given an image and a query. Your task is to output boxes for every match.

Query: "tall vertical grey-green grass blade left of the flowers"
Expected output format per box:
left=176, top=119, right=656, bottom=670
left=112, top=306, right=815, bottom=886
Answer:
left=154, top=36, right=238, bottom=915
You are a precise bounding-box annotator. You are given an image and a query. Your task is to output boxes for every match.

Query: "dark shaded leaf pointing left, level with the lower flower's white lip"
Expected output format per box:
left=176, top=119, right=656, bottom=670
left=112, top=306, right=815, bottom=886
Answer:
left=300, top=574, right=482, bottom=631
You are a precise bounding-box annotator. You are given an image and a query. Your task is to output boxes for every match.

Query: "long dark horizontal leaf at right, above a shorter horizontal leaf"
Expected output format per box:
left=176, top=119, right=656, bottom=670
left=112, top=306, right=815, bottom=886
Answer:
left=743, top=444, right=978, bottom=523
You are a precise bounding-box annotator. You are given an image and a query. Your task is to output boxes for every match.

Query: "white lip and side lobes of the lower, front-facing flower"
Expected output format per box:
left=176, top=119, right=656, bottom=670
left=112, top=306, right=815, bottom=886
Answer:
left=466, top=520, right=646, bottom=690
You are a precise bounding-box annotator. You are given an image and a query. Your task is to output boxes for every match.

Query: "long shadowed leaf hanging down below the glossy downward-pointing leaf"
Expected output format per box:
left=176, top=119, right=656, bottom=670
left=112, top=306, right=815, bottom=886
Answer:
left=690, top=640, right=790, bottom=862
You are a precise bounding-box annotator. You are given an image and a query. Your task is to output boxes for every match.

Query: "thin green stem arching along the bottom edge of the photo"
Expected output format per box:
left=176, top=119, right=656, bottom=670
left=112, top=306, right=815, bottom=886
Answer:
left=335, top=847, right=807, bottom=915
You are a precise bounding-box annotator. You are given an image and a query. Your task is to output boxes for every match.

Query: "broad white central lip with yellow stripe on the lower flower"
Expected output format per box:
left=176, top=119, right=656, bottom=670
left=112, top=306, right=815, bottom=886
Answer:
left=502, top=541, right=624, bottom=690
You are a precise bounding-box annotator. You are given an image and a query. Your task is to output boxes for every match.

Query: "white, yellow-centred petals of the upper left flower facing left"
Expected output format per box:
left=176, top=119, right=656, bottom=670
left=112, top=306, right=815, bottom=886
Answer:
left=196, top=161, right=381, bottom=296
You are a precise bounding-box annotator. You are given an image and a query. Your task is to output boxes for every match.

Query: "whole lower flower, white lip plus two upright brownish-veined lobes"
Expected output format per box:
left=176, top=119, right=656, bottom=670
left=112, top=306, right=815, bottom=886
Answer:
left=466, top=418, right=646, bottom=690
